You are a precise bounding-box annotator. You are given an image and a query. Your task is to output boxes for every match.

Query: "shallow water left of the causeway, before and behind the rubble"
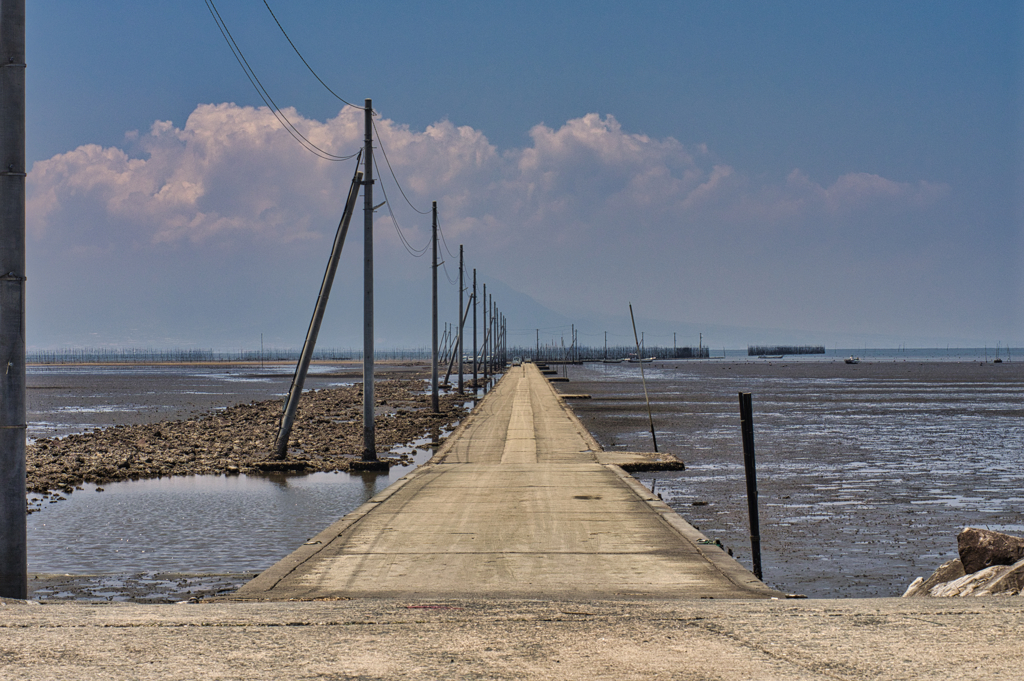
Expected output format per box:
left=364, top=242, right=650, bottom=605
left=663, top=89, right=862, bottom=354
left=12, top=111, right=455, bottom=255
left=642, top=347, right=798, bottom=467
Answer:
left=27, top=363, right=466, bottom=574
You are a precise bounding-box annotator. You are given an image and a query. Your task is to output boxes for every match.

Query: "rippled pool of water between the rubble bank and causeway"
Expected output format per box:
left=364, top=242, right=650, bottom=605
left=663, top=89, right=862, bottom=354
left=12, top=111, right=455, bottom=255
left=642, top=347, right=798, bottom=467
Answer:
left=28, top=448, right=433, bottom=574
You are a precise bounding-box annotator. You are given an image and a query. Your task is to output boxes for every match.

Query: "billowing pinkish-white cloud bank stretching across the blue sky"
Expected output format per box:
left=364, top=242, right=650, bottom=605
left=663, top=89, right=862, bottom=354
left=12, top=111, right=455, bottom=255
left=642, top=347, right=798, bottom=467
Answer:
left=29, top=103, right=945, bottom=245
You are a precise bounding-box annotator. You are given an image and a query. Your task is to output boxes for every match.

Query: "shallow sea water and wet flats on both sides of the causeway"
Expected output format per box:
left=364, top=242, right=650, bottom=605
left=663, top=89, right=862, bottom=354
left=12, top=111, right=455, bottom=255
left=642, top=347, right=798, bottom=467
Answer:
left=28, top=348, right=1024, bottom=597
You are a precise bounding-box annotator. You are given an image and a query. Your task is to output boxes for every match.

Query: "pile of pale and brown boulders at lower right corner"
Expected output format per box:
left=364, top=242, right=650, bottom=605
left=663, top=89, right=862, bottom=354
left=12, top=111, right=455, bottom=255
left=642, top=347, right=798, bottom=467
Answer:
left=903, top=527, right=1024, bottom=598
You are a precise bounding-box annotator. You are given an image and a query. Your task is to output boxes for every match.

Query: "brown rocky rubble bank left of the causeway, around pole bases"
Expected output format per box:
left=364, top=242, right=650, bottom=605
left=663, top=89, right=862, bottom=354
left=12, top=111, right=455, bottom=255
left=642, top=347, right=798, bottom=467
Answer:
left=26, top=379, right=466, bottom=512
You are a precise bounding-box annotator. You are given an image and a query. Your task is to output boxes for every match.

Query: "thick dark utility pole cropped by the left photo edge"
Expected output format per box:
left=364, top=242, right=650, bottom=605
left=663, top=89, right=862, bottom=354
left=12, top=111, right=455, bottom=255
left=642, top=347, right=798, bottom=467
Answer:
left=0, top=0, right=29, bottom=599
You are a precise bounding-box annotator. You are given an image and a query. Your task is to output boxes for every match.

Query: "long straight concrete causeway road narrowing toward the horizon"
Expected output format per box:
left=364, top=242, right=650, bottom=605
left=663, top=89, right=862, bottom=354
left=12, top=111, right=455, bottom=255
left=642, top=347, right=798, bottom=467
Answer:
left=234, top=364, right=782, bottom=600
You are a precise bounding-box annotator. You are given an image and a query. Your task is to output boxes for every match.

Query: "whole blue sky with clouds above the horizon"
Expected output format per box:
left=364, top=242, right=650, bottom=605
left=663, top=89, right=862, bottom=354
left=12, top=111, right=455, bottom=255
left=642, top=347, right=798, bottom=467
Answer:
left=27, top=0, right=1024, bottom=350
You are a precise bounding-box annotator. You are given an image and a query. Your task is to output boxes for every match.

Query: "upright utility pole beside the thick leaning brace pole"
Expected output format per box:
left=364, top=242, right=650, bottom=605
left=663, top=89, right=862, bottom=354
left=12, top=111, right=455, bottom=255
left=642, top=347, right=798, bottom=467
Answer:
left=362, top=99, right=377, bottom=461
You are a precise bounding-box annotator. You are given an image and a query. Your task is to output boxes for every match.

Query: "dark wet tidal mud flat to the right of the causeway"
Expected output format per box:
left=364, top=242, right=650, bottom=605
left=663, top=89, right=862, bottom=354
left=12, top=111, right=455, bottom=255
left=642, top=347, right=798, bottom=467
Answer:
left=555, top=357, right=1024, bottom=598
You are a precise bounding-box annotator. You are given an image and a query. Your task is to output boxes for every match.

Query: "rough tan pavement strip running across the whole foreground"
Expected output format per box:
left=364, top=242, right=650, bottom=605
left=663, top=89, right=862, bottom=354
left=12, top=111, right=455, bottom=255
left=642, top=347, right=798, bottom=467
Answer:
left=0, top=597, right=1024, bottom=681
